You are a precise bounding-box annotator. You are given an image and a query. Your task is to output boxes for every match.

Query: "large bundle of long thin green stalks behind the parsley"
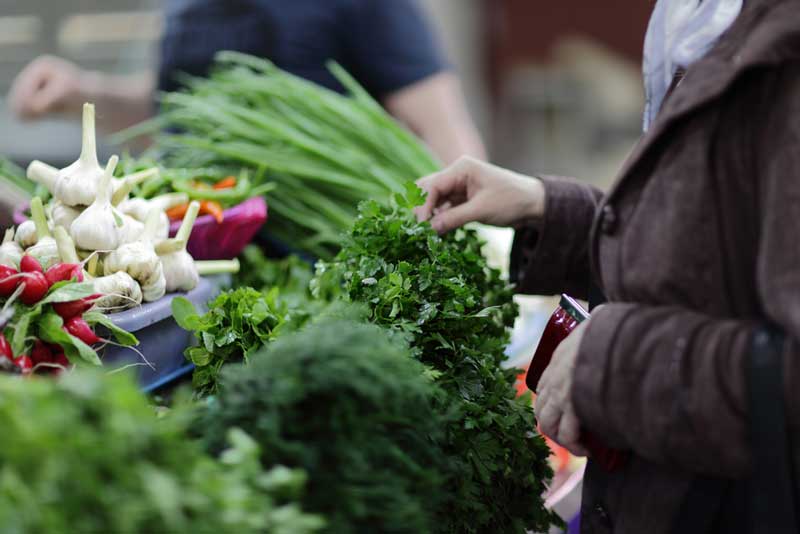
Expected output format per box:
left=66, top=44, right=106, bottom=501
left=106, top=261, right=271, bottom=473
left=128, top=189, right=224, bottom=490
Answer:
left=118, top=52, right=438, bottom=258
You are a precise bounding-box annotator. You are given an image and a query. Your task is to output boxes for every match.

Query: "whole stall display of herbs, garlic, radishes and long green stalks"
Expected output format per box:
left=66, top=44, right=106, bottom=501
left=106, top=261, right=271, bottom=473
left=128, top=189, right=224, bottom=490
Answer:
left=0, top=52, right=560, bottom=534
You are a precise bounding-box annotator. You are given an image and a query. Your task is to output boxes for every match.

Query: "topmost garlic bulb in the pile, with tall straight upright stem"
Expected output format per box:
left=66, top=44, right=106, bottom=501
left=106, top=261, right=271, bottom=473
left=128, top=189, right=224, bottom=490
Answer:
left=52, top=104, right=104, bottom=208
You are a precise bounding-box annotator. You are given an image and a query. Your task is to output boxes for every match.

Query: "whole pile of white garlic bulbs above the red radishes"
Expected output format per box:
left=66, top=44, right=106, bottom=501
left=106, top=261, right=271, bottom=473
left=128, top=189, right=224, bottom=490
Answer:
left=12, top=100, right=238, bottom=312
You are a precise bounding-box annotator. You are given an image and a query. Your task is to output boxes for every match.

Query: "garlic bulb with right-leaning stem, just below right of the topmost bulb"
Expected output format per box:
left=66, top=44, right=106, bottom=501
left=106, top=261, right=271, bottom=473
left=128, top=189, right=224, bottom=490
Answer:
left=69, top=156, right=123, bottom=250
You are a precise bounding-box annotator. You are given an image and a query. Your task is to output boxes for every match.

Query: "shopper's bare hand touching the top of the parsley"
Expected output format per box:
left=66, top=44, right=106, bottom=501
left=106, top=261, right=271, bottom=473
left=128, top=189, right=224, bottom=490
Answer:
left=416, top=157, right=544, bottom=234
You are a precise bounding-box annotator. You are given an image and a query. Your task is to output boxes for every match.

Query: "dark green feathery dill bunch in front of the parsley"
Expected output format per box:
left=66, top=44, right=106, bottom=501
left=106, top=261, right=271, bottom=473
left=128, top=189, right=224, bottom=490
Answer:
left=197, top=318, right=454, bottom=534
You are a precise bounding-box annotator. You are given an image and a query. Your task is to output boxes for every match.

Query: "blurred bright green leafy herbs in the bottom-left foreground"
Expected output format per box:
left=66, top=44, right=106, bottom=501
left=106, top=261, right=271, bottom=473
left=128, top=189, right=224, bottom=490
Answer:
left=0, top=373, right=322, bottom=534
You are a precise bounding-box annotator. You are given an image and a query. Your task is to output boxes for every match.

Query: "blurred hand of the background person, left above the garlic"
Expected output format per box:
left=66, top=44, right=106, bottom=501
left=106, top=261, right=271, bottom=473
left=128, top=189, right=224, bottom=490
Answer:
left=9, top=56, right=86, bottom=120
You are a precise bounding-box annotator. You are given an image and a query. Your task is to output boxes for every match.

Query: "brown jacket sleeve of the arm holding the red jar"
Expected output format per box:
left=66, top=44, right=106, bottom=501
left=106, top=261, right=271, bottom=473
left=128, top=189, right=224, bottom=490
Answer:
left=573, top=65, right=800, bottom=477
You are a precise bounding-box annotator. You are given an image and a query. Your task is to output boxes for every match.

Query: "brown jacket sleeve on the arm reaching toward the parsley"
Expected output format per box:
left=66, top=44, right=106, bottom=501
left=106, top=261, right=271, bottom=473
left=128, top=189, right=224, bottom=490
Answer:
left=510, top=176, right=603, bottom=299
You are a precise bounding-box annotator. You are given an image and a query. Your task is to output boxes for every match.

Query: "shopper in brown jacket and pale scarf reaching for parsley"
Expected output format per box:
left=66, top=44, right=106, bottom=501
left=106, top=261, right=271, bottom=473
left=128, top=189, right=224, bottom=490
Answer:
left=418, top=0, right=800, bottom=534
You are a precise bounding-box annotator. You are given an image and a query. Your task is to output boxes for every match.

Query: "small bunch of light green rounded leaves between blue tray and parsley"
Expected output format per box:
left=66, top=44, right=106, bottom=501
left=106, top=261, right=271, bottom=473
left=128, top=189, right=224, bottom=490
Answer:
left=172, top=287, right=294, bottom=395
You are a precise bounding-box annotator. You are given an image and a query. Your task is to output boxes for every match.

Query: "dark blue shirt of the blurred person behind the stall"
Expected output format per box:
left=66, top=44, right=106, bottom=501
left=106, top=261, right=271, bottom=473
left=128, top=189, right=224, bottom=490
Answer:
left=159, top=0, right=445, bottom=99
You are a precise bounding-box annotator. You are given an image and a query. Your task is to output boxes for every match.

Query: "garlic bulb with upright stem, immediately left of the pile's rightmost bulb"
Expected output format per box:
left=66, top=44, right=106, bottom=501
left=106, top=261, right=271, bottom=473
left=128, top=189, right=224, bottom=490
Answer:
left=103, top=210, right=167, bottom=302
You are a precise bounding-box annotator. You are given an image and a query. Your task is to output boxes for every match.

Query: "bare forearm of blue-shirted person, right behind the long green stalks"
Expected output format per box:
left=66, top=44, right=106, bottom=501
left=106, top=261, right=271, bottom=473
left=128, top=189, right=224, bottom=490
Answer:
left=384, top=72, right=486, bottom=165
